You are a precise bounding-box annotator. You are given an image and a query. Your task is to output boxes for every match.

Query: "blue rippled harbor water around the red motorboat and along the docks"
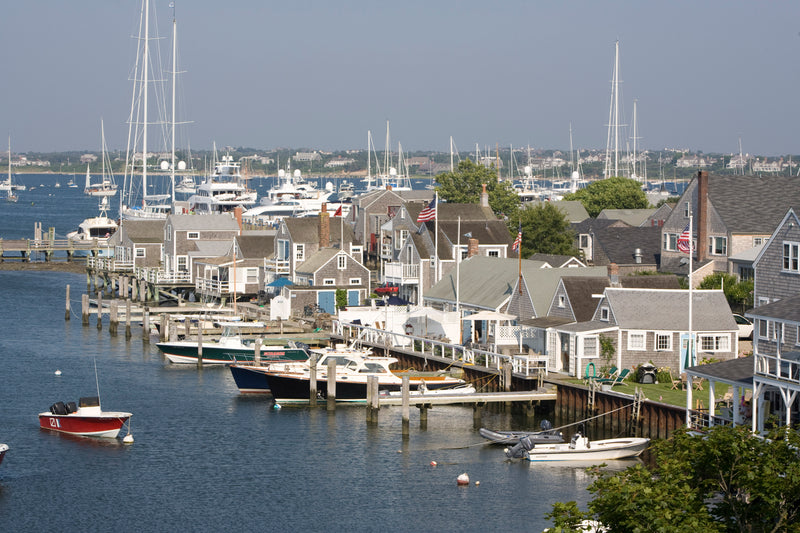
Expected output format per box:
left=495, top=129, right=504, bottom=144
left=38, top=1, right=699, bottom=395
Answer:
left=0, top=176, right=590, bottom=531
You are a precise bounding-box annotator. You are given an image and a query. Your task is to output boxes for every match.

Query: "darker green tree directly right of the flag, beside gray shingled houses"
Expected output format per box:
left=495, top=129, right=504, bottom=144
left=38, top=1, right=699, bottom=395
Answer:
left=508, top=202, right=578, bottom=257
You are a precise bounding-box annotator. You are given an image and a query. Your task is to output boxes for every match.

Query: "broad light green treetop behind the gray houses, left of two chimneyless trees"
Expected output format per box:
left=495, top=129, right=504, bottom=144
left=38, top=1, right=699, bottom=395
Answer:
left=436, top=159, right=520, bottom=218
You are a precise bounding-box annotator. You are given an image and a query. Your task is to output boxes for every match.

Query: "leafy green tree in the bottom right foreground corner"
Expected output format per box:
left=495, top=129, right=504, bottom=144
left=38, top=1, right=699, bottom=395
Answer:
left=547, top=426, right=800, bottom=533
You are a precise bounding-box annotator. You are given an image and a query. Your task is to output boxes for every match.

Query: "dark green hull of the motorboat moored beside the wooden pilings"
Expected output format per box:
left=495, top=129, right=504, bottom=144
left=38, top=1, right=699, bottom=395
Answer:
left=157, top=342, right=308, bottom=365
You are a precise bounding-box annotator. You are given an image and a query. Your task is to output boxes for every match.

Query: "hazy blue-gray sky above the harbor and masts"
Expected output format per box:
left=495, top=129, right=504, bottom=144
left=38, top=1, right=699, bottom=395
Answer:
left=0, top=0, right=800, bottom=156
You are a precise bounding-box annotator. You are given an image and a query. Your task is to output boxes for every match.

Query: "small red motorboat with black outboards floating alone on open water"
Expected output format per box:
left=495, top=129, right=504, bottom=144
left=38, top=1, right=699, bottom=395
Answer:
left=39, top=396, right=133, bottom=439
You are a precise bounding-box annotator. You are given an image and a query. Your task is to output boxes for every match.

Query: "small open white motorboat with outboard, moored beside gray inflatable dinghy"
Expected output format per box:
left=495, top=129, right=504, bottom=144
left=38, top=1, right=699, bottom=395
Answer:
left=505, top=424, right=650, bottom=463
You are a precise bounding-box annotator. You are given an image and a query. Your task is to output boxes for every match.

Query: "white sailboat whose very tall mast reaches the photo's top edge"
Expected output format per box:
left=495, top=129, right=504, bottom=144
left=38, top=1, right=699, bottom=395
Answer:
left=119, top=0, right=174, bottom=220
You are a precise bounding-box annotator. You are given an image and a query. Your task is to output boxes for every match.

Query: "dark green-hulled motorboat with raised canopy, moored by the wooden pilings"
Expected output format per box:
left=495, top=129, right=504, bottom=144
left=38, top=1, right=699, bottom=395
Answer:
left=156, top=322, right=308, bottom=365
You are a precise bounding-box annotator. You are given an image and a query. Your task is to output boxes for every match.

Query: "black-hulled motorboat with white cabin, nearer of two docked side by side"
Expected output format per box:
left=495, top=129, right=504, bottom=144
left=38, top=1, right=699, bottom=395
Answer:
left=252, top=344, right=466, bottom=403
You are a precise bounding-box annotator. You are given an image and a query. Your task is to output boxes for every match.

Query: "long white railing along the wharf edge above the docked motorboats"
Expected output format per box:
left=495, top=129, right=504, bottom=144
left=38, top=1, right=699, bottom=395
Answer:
left=332, top=320, right=548, bottom=377
